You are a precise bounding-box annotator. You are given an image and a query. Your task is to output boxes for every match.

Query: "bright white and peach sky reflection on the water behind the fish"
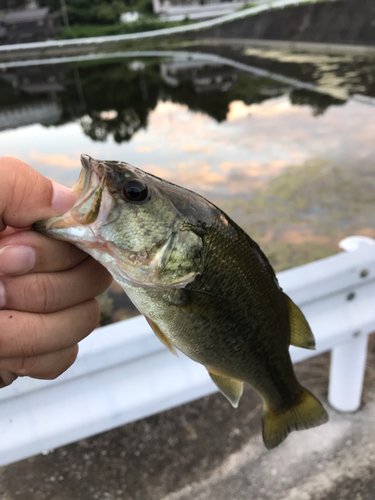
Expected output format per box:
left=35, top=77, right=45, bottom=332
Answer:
left=0, top=96, right=375, bottom=199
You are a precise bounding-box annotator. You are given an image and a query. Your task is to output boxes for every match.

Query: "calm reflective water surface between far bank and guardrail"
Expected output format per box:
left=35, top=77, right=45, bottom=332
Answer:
left=0, top=46, right=375, bottom=320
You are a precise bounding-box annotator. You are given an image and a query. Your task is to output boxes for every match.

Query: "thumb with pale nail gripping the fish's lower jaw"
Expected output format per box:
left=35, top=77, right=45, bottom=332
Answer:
left=0, top=158, right=77, bottom=231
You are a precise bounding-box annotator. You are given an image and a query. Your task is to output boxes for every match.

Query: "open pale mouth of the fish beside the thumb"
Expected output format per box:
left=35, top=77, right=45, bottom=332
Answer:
left=33, top=154, right=112, bottom=236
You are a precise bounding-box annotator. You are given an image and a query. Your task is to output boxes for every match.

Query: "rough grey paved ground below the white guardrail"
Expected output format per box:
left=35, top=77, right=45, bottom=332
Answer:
left=0, top=336, right=375, bottom=500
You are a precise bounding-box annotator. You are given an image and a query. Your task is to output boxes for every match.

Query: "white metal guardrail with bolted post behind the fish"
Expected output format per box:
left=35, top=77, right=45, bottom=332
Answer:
left=0, top=236, right=375, bottom=465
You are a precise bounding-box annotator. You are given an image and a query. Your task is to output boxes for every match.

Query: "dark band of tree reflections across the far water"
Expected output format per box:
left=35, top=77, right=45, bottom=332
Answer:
left=0, top=58, right=350, bottom=143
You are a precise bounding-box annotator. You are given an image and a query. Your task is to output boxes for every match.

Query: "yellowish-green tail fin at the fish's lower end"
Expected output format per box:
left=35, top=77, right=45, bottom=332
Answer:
left=263, top=387, right=328, bottom=450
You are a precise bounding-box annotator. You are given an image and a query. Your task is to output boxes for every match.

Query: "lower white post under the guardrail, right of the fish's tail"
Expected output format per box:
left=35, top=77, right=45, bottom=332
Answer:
left=328, top=333, right=368, bottom=412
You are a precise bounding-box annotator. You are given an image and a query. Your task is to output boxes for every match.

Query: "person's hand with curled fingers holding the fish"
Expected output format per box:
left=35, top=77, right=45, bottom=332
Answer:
left=0, top=158, right=112, bottom=387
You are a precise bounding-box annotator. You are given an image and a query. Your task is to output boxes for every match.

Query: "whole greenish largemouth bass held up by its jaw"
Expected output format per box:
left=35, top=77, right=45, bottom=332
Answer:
left=34, top=155, right=328, bottom=449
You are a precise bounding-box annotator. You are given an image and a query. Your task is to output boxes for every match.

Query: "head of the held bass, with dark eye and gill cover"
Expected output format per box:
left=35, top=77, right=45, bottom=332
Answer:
left=34, top=155, right=207, bottom=290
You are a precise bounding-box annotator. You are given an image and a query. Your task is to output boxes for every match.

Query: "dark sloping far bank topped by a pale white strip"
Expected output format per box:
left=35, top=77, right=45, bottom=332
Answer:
left=0, top=0, right=375, bottom=62
